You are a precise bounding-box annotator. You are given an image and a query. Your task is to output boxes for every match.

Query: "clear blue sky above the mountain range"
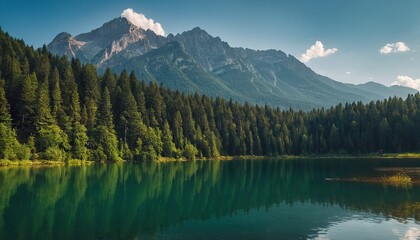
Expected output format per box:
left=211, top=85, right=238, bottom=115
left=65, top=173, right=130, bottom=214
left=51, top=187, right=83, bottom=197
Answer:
left=0, top=0, right=420, bottom=89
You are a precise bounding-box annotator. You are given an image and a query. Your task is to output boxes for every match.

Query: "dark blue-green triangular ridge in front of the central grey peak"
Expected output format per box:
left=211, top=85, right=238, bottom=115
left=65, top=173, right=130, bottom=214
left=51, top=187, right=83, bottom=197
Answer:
left=113, top=42, right=244, bottom=100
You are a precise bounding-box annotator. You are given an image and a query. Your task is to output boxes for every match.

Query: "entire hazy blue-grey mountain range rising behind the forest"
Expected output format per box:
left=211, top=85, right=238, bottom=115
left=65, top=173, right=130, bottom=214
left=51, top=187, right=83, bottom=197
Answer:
left=47, top=18, right=417, bottom=110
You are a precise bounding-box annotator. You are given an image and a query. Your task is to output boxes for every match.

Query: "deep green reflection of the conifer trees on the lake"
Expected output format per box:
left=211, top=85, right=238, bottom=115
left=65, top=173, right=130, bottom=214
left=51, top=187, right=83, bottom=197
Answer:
left=0, top=160, right=420, bottom=239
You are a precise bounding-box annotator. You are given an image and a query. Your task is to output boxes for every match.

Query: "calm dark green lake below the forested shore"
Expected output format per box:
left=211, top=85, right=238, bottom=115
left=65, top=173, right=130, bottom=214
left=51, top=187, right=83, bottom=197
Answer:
left=0, top=159, right=420, bottom=239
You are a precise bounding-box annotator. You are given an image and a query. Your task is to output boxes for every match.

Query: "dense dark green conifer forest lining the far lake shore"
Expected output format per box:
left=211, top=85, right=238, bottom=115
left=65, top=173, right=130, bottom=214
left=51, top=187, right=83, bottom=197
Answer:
left=0, top=31, right=420, bottom=161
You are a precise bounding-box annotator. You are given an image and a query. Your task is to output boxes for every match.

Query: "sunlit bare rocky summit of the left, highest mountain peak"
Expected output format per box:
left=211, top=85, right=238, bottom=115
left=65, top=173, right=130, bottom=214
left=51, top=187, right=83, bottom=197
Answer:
left=47, top=18, right=165, bottom=67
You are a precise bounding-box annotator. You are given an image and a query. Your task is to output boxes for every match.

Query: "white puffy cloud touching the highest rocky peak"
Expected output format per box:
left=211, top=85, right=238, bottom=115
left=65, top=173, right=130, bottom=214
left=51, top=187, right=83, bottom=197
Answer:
left=121, top=8, right=165, bottom=36
